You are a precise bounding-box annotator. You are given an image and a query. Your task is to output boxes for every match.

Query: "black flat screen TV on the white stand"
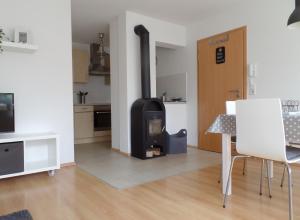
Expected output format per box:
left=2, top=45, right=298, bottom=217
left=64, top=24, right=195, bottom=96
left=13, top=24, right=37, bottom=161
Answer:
left=0, top=93, right=15, bottom=132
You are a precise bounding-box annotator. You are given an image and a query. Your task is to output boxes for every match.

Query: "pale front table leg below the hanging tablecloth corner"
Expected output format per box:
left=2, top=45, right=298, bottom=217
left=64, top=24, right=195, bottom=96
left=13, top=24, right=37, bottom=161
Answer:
left=222, top=134, right=231, bottom=195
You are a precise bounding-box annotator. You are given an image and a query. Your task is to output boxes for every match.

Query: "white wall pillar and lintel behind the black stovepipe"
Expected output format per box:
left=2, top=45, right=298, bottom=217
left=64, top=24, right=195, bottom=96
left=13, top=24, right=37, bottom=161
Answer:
left=110, top=12, right=186, bottom=153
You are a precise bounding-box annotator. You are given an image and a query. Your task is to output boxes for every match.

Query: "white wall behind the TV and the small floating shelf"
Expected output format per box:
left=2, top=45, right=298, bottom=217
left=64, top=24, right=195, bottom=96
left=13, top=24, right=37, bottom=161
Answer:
left=0, top=0, right=74, bottom=163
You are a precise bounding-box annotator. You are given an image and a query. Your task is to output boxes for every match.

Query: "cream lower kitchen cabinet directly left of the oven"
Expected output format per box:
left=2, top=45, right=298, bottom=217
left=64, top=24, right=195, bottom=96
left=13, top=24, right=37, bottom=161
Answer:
left=74, top=106, right=94, bottom=140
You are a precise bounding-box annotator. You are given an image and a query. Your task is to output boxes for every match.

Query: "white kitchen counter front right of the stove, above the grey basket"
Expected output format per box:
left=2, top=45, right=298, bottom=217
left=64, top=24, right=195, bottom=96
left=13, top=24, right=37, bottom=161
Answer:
left=164, top=102, right=187, bottom=134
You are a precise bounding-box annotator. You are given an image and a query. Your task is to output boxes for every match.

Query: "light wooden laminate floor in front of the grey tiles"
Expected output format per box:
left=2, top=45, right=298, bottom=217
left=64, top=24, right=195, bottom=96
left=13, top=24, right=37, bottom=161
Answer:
left=0, top=160, right=300, bottom=220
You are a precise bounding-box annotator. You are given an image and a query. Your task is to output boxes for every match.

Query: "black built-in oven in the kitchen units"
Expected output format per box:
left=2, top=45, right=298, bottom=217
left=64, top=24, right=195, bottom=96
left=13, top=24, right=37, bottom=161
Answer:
left=94, top=105, right=111, bottom=131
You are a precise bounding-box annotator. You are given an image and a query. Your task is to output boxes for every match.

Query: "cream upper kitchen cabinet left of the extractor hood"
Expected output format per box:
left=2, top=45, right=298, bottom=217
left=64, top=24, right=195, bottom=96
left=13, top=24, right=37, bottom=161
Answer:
left=73, top=48, right=89, bottom=83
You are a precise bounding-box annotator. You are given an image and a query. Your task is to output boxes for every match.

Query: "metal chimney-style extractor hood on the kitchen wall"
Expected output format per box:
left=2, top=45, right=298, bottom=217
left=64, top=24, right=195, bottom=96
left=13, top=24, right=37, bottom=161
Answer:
left=89, top=33, right=110, bottom=76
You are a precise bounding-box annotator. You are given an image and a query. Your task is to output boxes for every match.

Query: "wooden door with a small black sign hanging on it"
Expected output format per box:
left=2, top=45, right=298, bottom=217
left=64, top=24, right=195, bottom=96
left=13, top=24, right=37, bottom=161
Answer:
left=197, top=27, right=247, bottom=152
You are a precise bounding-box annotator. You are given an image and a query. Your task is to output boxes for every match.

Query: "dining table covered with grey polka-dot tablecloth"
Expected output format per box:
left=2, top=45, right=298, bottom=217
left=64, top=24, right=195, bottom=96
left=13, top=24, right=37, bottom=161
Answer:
left=206, top=112, right=300, bottom=195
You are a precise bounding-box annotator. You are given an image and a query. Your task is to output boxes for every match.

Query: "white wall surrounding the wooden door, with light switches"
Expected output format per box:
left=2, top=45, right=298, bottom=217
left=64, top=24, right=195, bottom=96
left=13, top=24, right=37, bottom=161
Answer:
left=184, top=0, right=300, bottom=145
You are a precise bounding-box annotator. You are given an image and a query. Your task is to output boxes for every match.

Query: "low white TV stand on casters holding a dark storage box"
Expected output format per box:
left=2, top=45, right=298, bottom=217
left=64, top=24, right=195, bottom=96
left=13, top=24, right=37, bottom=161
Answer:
left=0, top=133, right=60, bottom=179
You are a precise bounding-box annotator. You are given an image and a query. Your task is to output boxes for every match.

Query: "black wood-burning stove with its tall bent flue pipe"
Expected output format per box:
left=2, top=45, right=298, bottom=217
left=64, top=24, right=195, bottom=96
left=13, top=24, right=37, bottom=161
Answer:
left=131, top=25, right=166, bottom=159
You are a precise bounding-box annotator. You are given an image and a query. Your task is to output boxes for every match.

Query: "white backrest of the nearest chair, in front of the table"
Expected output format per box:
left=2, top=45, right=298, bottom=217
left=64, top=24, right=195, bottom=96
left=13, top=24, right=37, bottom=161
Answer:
left=236, top=99, right=287, bottom=162
